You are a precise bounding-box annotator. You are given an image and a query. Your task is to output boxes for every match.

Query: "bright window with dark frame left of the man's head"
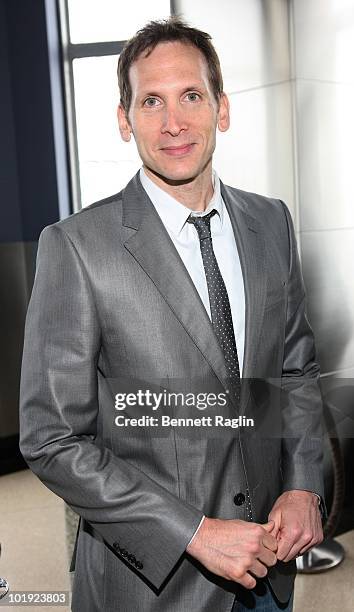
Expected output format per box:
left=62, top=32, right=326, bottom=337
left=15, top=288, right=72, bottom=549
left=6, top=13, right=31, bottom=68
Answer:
left=59, top=0, right=173, bottom=211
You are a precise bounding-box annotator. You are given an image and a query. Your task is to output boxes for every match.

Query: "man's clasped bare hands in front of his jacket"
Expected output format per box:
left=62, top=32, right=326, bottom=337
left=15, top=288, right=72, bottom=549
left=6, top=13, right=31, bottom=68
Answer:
left=187, top=490, right=323, bottom=589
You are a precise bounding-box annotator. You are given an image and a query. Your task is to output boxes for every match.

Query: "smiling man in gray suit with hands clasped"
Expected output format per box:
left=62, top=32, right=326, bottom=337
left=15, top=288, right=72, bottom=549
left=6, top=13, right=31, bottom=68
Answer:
left=21, top=19, right=323, bottom=612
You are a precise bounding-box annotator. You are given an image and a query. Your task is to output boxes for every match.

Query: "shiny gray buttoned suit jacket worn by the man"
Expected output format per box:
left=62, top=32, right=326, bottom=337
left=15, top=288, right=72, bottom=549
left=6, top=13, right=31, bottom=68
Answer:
left=20, top=175, right=323, bottom=612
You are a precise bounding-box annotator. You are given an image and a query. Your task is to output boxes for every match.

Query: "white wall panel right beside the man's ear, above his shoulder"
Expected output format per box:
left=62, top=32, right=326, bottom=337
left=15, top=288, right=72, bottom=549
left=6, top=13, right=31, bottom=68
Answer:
left=214, top=83, right=295, bottom=215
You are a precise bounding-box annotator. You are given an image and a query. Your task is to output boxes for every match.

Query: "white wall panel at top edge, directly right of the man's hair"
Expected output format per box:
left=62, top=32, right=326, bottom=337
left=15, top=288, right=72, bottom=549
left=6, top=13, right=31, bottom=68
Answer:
left=178, top=0, right=289, bottom=92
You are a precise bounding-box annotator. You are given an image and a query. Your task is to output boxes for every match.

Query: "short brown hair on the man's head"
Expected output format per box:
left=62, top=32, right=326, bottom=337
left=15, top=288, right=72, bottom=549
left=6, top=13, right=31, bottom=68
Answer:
left=117, top=17, right=223, bottom=113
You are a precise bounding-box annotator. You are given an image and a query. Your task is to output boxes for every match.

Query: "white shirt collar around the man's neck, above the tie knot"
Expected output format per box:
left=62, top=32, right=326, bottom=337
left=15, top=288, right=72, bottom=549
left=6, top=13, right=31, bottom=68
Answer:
left=139, top=168, right=224, bottom=236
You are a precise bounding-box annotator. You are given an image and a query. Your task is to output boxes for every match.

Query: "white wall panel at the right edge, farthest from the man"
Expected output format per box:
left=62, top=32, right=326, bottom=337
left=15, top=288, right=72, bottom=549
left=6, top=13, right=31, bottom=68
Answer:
left=296, top=81, right=354, bottom=231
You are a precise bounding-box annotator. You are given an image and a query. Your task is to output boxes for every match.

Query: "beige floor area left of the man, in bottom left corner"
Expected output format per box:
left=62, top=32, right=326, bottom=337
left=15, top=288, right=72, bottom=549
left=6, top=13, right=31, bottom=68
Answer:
left=0, top=470, right=70, bottom=612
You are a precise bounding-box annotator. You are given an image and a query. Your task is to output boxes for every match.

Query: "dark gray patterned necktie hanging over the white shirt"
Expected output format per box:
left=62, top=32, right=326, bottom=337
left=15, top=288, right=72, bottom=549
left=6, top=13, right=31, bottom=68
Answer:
left=187, top=209, right=241, bottom=405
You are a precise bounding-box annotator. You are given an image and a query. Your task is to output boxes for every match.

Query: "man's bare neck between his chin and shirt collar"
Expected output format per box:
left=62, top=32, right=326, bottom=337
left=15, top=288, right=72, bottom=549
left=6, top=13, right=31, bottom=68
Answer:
left=143, top=163, right=214, bottom=212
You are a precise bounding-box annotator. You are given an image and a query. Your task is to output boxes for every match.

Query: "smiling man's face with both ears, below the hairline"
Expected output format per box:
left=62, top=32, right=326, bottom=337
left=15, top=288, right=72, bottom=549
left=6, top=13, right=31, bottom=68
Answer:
left=118, top=42, right=229, bottom=183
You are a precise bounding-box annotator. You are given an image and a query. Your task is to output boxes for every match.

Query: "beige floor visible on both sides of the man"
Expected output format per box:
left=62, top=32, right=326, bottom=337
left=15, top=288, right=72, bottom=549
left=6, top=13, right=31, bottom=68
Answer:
left=0, top=470, right=354, bottom=612
